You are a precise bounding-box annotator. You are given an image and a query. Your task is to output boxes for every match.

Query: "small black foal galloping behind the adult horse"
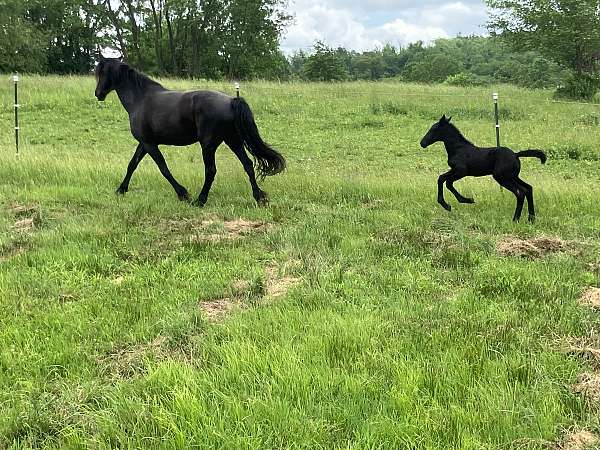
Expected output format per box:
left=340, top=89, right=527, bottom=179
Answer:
left=421, top=115, right=546, bottom=222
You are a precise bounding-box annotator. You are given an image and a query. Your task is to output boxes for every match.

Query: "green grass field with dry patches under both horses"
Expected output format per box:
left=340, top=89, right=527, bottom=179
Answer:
left=0, top=77, right=600, bottom=449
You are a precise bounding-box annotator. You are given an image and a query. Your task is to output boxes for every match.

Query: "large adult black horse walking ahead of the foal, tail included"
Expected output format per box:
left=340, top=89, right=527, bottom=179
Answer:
left=95, top=56, right=285, bottom=206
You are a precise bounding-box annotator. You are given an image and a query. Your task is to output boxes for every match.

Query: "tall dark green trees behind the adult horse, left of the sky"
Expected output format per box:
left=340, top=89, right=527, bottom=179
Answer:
left=0, top=0, right=291, bottom=78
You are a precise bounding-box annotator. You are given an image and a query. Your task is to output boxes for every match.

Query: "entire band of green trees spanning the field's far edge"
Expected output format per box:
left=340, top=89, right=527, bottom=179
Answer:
left=0, top=0, right=600, bottom=99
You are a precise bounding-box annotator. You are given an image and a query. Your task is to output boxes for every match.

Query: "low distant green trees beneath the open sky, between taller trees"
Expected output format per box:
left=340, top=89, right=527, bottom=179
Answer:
left=290, top=36, right=567, bottom=88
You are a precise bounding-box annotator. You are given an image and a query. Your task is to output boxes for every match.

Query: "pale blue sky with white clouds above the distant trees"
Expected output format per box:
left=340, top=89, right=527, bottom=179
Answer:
left=282, top=0, right=487, bottom=53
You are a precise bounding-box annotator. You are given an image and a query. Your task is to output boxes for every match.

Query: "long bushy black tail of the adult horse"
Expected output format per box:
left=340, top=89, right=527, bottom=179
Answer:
left=231, top=97, right=285, bottom=177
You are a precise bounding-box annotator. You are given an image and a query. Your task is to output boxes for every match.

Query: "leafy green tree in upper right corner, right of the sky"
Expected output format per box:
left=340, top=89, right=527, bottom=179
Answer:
left=487, top=0, right=600, bottom=98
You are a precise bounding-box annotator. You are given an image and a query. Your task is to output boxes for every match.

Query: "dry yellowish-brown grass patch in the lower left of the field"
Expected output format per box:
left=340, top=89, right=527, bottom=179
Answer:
left=96, top=336, right=185, bottom=379
